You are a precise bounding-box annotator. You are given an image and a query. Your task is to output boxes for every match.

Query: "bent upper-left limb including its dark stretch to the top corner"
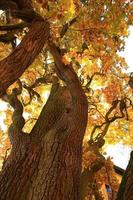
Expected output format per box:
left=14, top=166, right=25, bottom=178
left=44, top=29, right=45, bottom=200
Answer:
left=0, top=0, right=50, bottom=96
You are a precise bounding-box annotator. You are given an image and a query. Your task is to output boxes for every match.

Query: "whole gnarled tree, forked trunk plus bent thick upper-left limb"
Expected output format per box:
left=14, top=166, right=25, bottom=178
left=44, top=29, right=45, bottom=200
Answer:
left=0, top=0, right=88, bottom=200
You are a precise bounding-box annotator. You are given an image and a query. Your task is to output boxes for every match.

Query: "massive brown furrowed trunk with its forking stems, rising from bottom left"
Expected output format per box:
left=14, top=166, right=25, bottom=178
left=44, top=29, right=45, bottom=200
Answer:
left=0, top=43, right=88, bottom=200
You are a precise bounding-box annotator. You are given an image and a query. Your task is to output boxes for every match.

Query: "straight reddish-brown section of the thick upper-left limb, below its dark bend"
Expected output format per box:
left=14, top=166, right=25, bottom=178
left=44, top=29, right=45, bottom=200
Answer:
left=0, top=19, right=49, bottom=96
